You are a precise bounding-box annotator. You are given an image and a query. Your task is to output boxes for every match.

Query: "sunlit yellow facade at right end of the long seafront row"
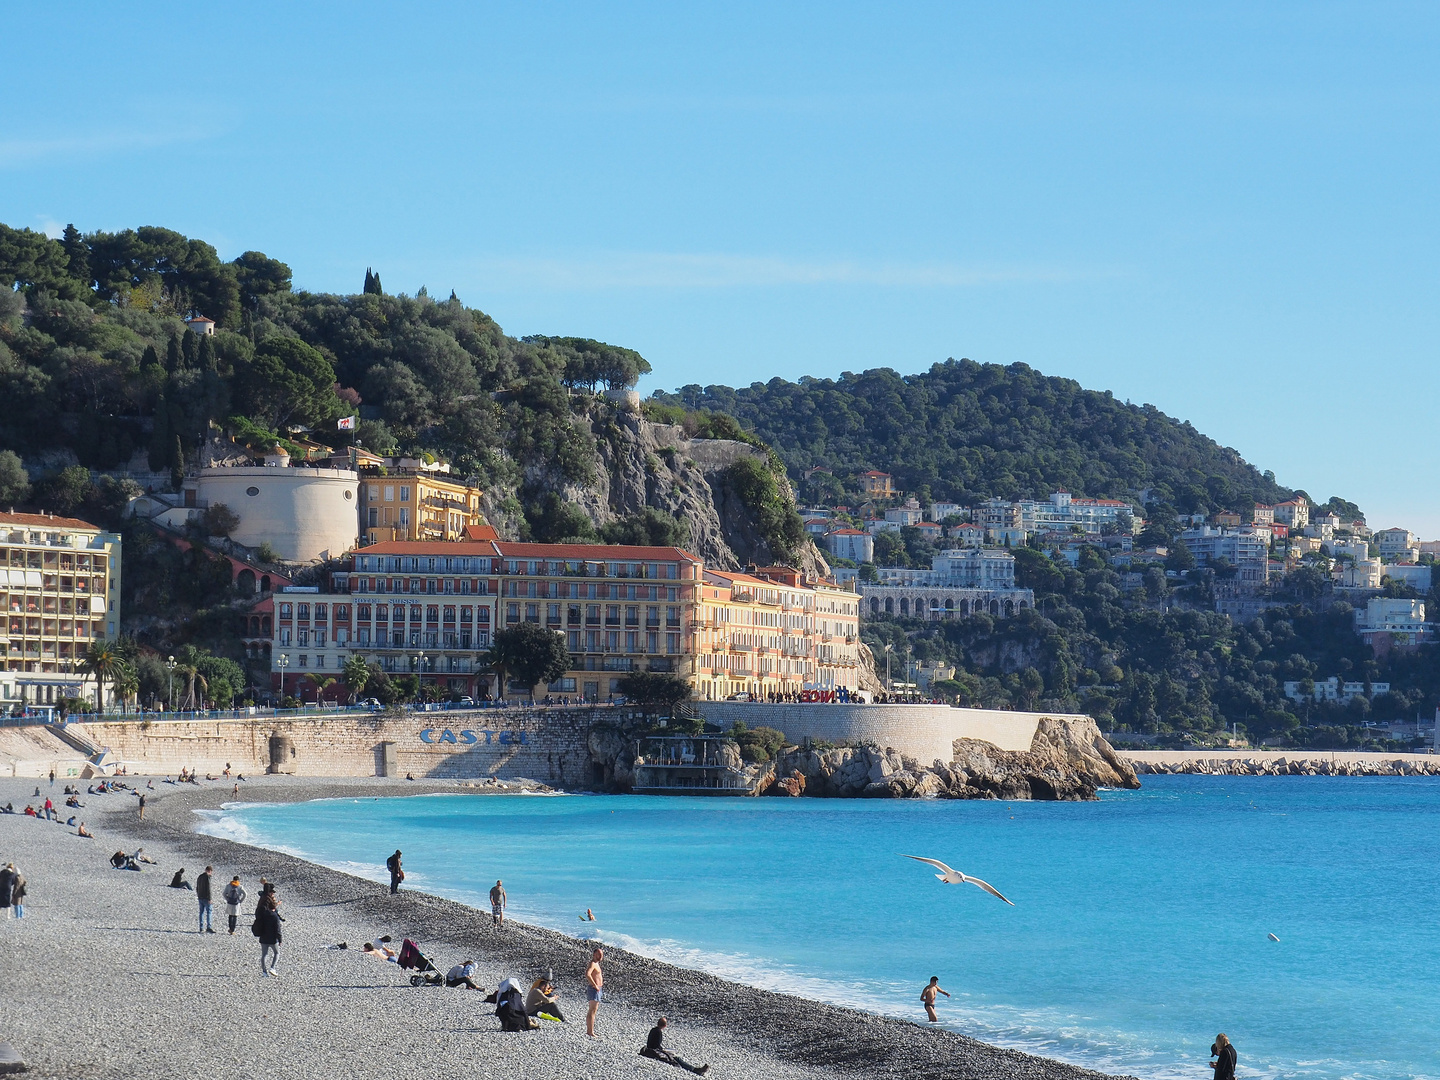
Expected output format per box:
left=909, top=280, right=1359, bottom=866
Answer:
left=693, top=567, right=860, bottom=701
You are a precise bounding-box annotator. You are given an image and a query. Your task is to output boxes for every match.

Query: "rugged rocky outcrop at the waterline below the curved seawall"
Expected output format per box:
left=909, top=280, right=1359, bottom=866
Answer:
left=768, top=717, right=1140, bottom=801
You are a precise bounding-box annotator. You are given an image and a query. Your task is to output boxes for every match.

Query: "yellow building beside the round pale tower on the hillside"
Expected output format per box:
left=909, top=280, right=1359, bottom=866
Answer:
left=360, top=462, right=485, bottom=546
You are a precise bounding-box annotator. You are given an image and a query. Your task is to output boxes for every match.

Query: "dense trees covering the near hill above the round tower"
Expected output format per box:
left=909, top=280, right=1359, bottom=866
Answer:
left=0, top=226, right=649, bottom=511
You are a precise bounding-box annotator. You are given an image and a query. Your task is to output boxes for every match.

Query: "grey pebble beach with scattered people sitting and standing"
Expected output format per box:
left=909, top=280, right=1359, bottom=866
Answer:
left=0, top=776, right=1128, bottom=1080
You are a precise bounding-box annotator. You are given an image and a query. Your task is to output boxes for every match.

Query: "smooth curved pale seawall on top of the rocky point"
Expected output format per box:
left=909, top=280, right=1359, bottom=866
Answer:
left=698, top=701, right=1089, bottom=763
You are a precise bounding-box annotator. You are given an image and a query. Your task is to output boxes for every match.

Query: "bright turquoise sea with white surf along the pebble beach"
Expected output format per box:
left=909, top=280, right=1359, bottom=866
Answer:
left=203, top=776, right=1440, bottom=1080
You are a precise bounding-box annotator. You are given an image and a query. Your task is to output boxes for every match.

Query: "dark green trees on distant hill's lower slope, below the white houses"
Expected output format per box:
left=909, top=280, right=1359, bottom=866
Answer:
left=863, top=549, right=1440, bottom=746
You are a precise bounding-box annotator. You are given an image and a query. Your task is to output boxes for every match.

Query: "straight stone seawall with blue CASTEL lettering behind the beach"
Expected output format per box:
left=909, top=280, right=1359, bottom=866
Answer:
left=46, top=707, right=648, bottom=788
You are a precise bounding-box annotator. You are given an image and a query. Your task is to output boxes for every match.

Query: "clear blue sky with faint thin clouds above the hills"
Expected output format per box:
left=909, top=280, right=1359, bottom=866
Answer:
left=0, top=3, right=1440, bottom=539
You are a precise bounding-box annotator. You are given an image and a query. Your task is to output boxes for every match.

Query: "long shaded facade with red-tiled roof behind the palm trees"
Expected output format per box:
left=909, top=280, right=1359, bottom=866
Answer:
left=271, top=541, right=701, bottom=701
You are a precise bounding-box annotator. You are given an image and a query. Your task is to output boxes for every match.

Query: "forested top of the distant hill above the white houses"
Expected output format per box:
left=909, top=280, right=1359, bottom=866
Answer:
left=655, top=360, right=1289, bottom=510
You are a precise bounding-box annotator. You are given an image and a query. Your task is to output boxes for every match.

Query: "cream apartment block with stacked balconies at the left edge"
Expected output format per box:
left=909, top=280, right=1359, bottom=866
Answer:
left=0, top=514, right=120, bottom=704
